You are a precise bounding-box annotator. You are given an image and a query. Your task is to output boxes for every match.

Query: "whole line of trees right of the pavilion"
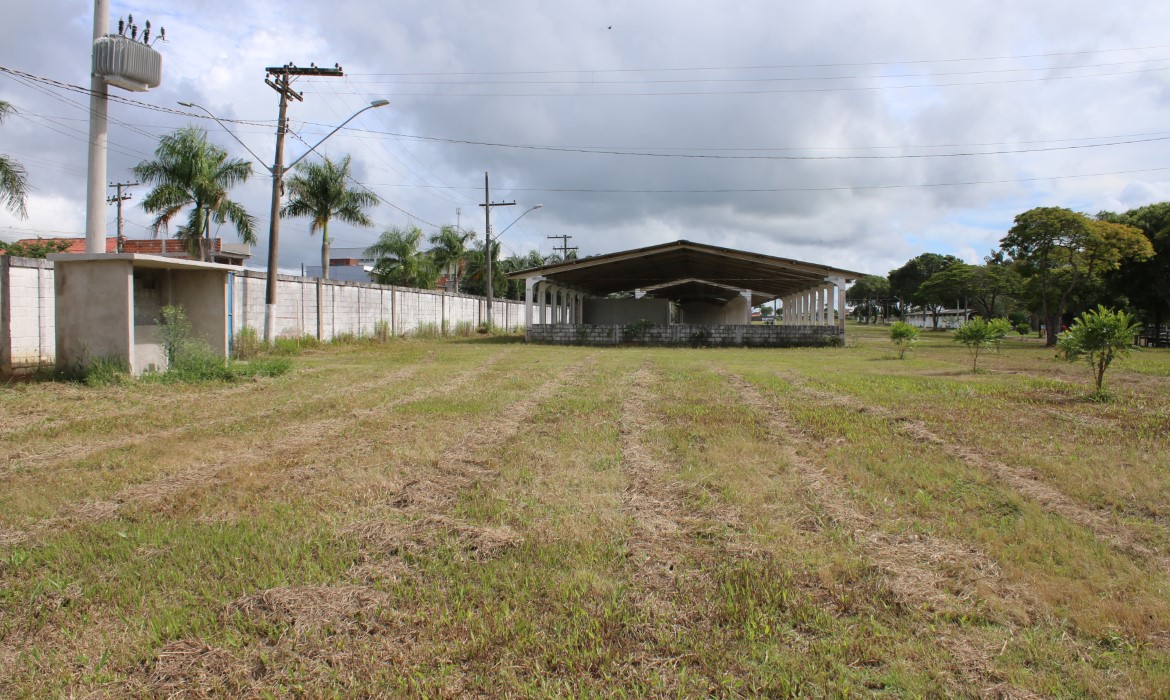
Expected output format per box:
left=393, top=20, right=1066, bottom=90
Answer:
left=847, top=203, right=1170, bottom=345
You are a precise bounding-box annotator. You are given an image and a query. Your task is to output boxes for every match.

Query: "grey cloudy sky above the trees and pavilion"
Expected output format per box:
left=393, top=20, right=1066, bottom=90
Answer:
left=0, top=0, right=1170, bottom=274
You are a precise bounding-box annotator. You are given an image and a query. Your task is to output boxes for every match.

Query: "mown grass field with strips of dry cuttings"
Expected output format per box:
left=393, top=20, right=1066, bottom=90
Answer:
left=0, top=327, right=1170, bottom=698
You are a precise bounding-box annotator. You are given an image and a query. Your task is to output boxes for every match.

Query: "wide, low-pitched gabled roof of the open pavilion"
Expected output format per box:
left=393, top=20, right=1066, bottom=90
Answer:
left=508, top=241, right=863, bottom=304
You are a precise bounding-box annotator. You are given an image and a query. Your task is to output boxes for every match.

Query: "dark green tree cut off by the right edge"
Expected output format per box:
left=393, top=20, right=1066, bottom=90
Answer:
left=1097, top=201, right=1170, bottom=328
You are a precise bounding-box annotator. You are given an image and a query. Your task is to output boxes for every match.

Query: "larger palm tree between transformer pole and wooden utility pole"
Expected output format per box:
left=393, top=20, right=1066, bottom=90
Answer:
left=133, top=126, right=256, bottom=260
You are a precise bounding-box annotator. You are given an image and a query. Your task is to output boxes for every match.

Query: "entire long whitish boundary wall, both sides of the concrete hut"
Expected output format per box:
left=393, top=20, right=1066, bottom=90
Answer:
left=0, top=255, right=524, bottom=378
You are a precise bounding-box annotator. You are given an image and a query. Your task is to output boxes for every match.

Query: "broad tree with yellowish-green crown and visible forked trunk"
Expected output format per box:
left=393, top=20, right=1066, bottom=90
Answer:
left=1000, top=207, right=1154, bottom=345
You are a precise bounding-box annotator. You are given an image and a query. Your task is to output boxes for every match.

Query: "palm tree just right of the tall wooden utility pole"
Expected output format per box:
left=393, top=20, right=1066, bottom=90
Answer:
left=281, top=156, right=378, bottom=280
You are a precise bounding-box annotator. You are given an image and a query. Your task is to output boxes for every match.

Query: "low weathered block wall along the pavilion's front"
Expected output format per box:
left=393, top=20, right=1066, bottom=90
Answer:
left=525, top=323, right=844, bottom=348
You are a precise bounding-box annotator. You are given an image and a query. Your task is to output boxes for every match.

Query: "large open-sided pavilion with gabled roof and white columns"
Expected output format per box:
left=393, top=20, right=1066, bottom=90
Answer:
left=509, top=241, right=862, bottom=346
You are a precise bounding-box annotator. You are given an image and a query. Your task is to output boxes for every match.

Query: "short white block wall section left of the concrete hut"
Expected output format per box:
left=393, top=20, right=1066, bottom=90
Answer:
left=0, top=255, right=56, bottom=377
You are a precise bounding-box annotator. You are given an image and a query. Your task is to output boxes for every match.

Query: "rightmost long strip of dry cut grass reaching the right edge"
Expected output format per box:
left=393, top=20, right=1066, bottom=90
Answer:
left=784, top=372, right=1170, bottom=572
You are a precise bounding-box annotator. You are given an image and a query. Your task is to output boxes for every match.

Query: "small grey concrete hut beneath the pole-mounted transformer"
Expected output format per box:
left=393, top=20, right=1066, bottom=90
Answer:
left=49, top=253, right=239, bottom=375
